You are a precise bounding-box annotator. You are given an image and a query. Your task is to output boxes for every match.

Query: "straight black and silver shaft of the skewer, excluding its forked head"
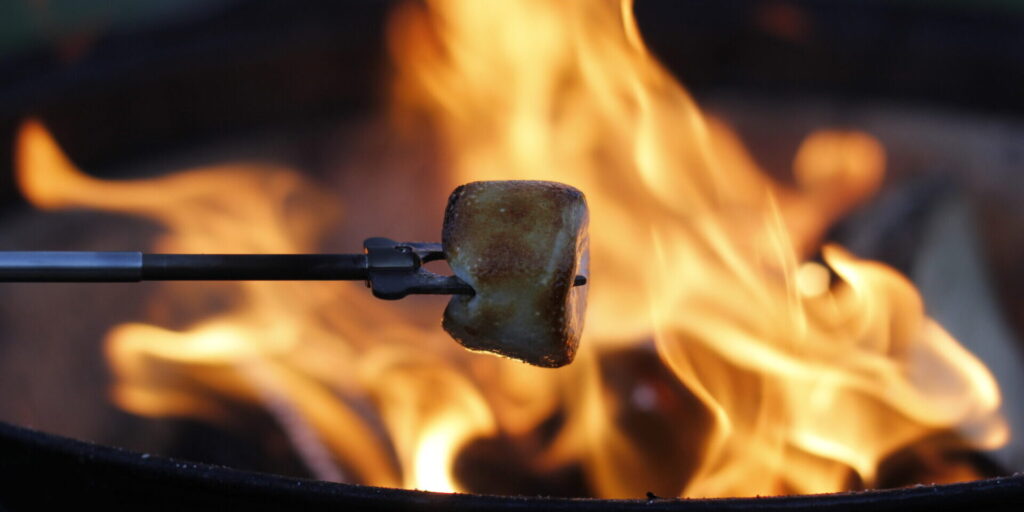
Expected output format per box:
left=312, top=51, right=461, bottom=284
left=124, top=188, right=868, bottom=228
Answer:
left=0, top=251, right=369, bottom=283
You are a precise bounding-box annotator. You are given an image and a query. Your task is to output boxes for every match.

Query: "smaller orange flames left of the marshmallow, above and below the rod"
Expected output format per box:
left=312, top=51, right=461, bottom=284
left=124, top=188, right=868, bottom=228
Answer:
left=17, top=121, right=493, bottom=490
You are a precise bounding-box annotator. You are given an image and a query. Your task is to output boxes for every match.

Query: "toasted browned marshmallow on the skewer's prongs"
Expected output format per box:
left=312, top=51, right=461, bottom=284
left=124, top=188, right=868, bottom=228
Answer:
left=441, top=181, right=589, bottom=368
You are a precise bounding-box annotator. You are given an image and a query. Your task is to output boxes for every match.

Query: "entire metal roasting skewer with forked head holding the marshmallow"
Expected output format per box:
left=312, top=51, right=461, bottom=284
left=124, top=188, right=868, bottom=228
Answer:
left=0, top=238, right=587, bottom=300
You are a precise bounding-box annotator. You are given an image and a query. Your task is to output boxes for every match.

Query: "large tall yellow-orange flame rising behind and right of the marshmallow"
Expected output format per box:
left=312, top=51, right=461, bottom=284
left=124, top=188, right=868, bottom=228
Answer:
left=392, top=0, right=1007, bottom=497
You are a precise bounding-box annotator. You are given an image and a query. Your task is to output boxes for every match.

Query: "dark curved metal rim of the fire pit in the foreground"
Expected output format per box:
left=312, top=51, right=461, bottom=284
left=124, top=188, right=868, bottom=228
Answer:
left=0, top=423, right=1024, bottom=512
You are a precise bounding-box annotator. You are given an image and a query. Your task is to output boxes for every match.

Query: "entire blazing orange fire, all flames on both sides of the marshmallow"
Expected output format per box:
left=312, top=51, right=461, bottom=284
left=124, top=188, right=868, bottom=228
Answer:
left=17, top=0, right=1008, bottom=498
